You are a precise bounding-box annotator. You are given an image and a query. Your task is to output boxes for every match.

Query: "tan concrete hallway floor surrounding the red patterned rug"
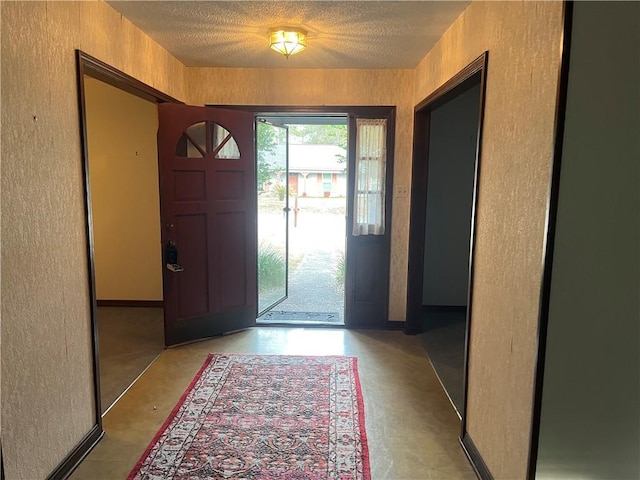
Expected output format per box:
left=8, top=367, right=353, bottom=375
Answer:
left=71, top=327, right=476, bottom=480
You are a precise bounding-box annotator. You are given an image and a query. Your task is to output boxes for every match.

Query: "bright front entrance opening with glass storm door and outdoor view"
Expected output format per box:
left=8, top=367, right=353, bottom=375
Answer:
left=256, top=114, right=348, bottom=326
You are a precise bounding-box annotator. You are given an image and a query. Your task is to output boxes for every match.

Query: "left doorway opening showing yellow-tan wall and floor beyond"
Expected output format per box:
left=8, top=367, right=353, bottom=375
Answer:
left=82, top=69, right=164, bottom=414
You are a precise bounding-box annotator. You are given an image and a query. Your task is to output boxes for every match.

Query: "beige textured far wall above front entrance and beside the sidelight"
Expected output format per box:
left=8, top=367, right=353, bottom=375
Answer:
left=187, top=68, right=414, bottom=320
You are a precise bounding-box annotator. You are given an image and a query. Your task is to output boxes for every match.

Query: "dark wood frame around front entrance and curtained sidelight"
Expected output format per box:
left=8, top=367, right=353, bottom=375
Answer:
left=211, top=103, right=398, bottom=329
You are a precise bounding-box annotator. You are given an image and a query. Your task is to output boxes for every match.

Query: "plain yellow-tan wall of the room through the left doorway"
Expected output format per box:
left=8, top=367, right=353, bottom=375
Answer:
left=84, top=77, right=162, bottom=300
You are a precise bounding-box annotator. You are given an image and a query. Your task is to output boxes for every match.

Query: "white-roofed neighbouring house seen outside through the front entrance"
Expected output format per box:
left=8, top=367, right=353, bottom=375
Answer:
left=264, top=144, right=347, bottom=197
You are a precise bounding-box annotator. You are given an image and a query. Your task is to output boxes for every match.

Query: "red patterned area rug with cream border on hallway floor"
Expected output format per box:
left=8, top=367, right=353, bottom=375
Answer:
left=128, top=354, right=371, bottom=480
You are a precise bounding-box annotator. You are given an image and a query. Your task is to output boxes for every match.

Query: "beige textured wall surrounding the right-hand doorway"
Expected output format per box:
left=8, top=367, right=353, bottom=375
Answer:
left=414, top=2, right=562, bottom=480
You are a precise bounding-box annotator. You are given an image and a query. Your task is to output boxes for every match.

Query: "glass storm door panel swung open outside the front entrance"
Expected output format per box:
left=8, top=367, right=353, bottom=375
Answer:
left=256, top=118, right=292, bottom=316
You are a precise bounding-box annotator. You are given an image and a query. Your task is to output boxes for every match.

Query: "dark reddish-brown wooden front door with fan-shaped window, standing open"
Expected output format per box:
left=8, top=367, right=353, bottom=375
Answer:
left=158, top=104, right=257, bottom=345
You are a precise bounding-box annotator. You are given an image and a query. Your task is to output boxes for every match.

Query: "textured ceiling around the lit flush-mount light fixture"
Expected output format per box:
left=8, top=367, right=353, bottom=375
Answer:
left=108, top=0, right=470, bottom=68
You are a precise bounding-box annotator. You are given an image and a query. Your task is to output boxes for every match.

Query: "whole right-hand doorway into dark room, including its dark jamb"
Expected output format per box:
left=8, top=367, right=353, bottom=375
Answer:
left=407, top=54, right=486, bottom=418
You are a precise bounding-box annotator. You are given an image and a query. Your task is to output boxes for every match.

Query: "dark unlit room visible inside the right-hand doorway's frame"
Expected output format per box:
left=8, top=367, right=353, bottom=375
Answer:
left=421, top=78, right=480, bottom=411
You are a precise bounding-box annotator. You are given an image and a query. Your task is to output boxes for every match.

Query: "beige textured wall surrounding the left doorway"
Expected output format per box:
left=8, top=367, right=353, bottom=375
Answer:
left=1, top=1, right=184, bottom=480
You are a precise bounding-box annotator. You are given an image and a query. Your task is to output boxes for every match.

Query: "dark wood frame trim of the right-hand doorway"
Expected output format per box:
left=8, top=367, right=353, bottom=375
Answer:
left=405, top=51, right=489, bottom=470
